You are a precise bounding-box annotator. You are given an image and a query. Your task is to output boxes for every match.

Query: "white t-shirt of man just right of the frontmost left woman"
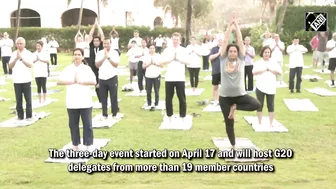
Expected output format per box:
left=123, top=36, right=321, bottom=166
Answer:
left=96, top=49, right=120, bottom=80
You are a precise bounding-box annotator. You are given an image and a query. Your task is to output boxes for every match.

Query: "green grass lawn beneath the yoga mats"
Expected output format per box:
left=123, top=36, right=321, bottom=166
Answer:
left=0, top=54, right=336, bottom=189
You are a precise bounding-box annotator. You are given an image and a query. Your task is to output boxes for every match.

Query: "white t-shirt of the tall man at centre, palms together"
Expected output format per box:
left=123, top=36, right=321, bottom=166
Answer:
left=162, top=46, right=189, bottom=82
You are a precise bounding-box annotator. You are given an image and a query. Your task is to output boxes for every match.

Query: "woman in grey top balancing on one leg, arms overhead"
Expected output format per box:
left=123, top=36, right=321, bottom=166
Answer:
left=219, top=14, right=260, bottom=148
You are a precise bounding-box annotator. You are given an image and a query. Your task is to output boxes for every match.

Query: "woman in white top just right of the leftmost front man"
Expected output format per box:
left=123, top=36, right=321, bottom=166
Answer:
left=33, top=41, right=49, bottom=103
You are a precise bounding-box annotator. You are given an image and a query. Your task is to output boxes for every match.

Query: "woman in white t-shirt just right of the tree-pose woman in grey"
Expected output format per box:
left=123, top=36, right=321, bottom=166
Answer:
left=252, top=46, right=282, bottom=127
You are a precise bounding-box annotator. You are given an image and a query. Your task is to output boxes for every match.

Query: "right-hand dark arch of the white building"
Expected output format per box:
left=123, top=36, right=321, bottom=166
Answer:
left=62, top=8, right=97, bottom=27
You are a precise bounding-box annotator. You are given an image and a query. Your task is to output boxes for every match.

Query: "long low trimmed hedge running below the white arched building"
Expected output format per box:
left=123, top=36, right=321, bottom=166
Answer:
left=0, top=26, right=184, bottom=52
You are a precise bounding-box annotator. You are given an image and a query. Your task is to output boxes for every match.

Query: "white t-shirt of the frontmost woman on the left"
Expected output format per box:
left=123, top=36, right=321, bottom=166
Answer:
left=59, top=64, right=96, bottom=109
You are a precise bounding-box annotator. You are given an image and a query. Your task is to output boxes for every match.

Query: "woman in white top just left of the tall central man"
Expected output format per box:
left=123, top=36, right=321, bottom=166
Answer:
left=142, top=44, right=162, bottom=111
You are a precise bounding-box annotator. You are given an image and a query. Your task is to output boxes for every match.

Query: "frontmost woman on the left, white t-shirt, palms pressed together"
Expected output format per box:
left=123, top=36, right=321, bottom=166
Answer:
left=57, top=48, right=96, bottom=150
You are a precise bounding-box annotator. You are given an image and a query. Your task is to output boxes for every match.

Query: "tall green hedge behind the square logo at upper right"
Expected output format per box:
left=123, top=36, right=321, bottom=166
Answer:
left=275, top=6, right=336, bottom=34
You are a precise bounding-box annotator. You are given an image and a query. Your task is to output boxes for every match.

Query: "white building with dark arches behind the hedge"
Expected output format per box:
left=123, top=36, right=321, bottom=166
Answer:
left=0, top=0, right=178, bottom=28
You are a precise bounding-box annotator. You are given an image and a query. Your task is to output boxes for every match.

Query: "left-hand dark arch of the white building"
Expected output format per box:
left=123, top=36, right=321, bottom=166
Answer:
left=10, top=9, right=41, bottom=27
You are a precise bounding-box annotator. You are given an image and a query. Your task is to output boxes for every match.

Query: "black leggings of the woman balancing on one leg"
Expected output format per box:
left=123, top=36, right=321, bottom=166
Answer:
left=219, top=95, right=260, bottom=146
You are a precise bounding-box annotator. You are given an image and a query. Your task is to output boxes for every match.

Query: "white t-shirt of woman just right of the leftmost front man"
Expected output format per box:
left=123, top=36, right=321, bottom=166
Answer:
left=33, top=51, right=49, bottom=77
